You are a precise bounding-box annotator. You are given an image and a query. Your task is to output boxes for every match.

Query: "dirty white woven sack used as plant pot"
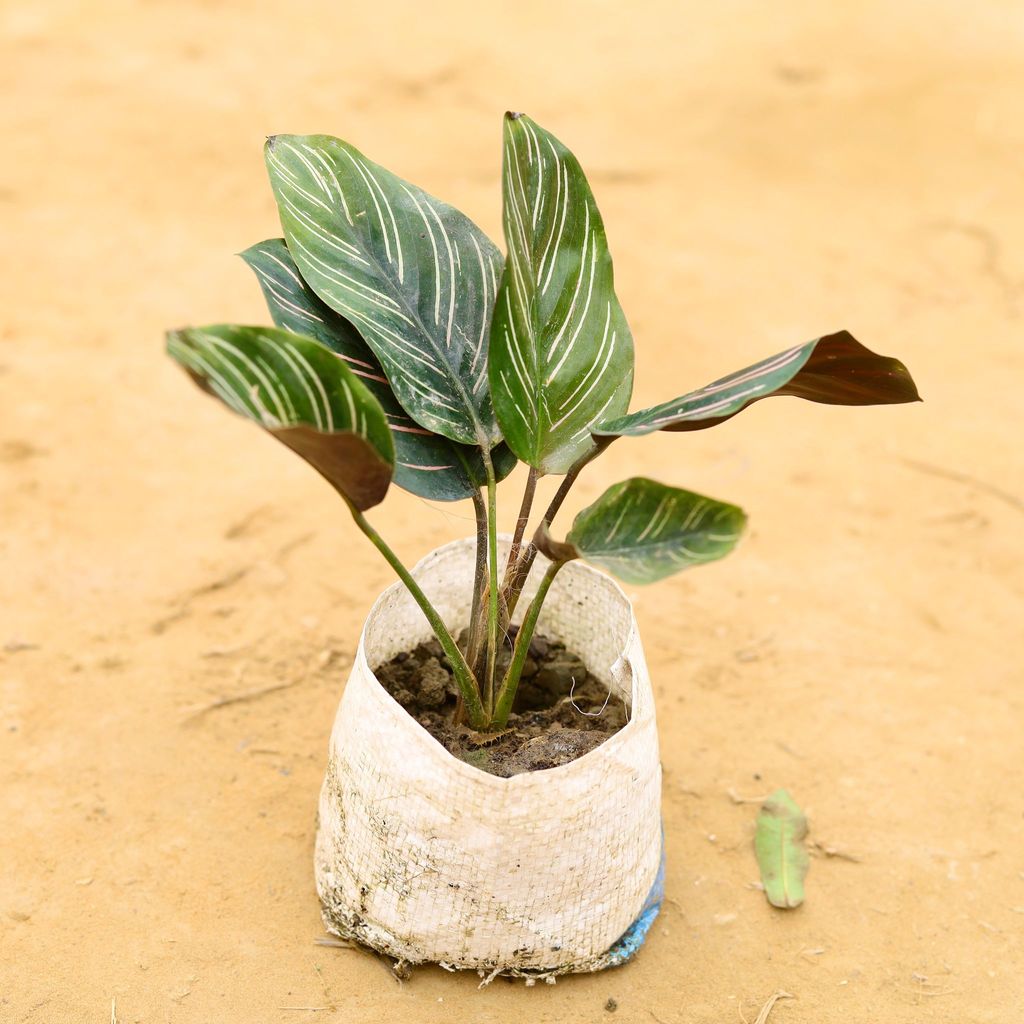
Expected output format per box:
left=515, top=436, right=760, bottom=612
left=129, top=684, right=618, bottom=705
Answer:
left=315, top=540, right=662, bottom=975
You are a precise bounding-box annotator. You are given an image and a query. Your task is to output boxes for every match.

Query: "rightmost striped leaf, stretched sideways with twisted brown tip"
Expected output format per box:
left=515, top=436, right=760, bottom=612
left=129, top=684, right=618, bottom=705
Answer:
left=594, top=331, right=921, bottom=438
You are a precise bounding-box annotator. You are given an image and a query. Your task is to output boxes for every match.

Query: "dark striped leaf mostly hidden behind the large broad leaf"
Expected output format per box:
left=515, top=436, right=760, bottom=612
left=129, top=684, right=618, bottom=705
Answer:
left=242, top=239, right=516, bottom=502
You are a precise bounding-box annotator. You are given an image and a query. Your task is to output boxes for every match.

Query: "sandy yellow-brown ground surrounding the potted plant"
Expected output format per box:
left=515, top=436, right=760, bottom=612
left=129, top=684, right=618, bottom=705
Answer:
left=0, top=0, right=1024, bottom=1024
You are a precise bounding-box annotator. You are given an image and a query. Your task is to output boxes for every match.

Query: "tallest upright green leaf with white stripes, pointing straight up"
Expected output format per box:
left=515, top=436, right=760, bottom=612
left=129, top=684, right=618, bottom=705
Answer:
left=488, top=114, right=633, bottom=473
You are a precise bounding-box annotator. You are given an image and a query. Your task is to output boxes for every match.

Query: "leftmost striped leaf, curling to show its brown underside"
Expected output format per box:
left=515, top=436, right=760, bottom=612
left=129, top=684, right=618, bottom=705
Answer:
left=167, top=324, right=394, bottom=511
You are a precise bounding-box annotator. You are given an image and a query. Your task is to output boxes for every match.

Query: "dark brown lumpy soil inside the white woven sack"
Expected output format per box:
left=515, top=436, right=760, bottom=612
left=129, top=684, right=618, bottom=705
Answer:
left=374, top=637, right=629, bottom=778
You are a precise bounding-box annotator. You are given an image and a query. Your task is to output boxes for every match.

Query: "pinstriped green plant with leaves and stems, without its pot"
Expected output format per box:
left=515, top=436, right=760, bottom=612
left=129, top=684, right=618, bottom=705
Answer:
left=168, top=114, right=919, bottom=730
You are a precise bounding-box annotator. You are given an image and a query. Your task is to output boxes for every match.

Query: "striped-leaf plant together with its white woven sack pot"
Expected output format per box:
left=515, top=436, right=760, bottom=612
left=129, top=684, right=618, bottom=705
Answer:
left=168, top=114, right=918, bottom=978
